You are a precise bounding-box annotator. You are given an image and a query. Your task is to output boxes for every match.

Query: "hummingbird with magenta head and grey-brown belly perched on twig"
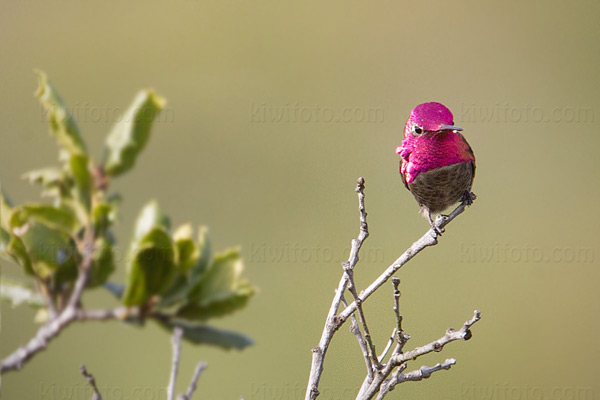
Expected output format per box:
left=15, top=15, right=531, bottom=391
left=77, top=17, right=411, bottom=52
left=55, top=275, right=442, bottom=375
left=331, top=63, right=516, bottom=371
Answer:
left=396, top=103, right=475, bottom=235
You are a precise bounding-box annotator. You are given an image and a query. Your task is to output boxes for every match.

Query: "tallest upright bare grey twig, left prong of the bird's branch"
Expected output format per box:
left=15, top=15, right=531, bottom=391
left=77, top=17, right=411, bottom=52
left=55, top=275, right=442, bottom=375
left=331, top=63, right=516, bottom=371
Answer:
left=306, top=177, right=369, bottom=400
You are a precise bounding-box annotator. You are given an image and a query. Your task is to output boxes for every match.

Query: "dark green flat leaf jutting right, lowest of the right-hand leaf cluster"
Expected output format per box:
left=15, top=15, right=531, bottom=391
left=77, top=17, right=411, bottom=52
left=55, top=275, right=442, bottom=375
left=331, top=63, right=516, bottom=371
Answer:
left=158, top=321, right=254, bottom=350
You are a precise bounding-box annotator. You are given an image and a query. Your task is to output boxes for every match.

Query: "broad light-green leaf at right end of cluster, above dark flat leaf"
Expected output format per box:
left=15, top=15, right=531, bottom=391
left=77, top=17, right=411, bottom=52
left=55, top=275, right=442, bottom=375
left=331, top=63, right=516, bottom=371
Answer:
left=177, top=250, right=255, bottom=320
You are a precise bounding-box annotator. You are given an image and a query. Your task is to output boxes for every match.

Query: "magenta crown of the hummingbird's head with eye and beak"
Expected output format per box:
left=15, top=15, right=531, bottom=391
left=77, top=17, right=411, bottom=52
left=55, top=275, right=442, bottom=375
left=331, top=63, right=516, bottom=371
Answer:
left=406, top=102, right=462, bottom=134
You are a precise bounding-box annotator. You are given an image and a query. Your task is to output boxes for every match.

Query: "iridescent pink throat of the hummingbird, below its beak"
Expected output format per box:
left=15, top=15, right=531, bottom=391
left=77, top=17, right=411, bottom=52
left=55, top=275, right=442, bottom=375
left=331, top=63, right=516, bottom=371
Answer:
left=396, top=131, right=475, bottom=183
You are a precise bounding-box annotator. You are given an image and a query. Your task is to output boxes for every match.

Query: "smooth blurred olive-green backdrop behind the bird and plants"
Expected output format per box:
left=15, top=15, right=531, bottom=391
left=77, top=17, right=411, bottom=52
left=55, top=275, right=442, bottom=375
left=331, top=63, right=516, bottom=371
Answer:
left=0, top=0, right=600, bottom=400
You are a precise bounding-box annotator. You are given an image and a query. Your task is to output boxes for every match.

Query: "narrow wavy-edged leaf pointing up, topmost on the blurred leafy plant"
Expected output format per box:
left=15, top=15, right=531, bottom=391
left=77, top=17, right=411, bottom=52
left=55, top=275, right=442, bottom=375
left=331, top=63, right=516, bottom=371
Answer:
left=36, top=71, right=86, bottom=154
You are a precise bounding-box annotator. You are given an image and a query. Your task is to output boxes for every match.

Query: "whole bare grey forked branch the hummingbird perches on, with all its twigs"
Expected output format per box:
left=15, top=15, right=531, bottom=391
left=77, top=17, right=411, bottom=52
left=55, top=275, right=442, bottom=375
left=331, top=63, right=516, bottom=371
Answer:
left=305, top=177, right=481, bottom=400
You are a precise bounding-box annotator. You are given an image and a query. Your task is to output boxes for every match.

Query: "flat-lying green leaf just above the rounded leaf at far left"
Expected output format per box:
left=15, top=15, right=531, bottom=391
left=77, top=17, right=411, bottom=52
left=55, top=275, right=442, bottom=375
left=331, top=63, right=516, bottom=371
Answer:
left=10, top=204, right=78, bottom=234
